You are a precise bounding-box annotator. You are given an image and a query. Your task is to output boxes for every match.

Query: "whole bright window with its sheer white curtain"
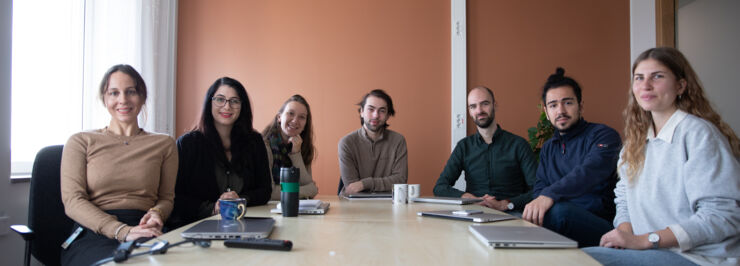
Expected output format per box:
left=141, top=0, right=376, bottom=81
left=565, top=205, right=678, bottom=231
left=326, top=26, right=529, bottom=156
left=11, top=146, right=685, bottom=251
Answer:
left=11, top=0, right=177, bottom=176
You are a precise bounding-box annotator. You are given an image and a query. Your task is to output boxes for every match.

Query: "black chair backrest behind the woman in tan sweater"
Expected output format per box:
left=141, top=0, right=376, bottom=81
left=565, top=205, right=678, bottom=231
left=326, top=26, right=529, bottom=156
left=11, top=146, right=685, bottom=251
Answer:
left=28, top=145, right=74, bottom=265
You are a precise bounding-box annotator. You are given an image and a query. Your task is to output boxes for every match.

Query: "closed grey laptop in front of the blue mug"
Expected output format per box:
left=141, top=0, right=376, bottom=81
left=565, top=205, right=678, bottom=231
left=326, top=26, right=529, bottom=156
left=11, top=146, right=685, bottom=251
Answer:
left=180, top=217, right=275, bottom=240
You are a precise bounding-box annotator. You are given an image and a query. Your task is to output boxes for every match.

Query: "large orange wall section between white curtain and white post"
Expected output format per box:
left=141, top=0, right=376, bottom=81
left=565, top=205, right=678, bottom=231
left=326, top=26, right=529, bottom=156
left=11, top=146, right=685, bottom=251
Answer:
left=176, top=0, right=450, bottom=195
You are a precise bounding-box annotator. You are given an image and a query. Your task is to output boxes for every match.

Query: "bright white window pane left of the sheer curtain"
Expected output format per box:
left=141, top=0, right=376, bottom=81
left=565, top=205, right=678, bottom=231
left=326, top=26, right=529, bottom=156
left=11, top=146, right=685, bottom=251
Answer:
left=11, top=0, right=84, bottom=175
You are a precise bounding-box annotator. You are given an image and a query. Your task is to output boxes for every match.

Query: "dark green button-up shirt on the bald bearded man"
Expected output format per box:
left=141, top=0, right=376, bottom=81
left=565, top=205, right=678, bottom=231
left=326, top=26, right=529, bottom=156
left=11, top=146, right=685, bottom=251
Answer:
left=434, top=125, right=537, bottom=210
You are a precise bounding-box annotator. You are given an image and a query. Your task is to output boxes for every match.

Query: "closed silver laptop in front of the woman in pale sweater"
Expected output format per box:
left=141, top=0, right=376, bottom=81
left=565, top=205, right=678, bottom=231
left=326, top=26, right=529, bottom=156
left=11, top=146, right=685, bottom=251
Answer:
left=468, top=225, right=578, bottom=248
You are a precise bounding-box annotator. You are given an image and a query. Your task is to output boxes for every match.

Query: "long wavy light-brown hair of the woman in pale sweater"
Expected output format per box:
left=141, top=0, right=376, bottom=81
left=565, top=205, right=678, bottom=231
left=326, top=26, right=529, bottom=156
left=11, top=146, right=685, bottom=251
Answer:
left=620, top=47, right=740, bottom=182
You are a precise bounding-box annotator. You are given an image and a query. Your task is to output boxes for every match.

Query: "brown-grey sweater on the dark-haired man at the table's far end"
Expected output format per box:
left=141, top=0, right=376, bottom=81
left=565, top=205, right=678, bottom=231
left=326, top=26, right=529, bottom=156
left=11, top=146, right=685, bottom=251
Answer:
left=338, top=127, right=409, bottom=193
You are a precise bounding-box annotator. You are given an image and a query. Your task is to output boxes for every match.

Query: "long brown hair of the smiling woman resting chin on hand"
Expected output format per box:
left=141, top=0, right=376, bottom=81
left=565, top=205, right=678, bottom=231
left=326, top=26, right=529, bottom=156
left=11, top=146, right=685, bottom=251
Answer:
left=262, top=94, right=316, bottom=167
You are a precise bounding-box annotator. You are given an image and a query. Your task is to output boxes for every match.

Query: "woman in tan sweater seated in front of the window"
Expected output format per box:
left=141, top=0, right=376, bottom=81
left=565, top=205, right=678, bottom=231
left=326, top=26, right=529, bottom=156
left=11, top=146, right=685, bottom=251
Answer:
left=59, top=65, right=178, bottom=265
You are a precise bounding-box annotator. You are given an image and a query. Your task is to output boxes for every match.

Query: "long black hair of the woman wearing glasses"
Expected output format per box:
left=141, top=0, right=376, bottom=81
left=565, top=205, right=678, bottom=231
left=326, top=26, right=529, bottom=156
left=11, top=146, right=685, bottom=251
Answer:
left=193, top=77, right=261, bottom=172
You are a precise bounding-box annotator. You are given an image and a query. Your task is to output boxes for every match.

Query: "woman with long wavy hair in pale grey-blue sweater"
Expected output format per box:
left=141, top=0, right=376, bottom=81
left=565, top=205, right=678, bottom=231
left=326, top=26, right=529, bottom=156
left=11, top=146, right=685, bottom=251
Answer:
left=584, top=48, right=740, bottom=265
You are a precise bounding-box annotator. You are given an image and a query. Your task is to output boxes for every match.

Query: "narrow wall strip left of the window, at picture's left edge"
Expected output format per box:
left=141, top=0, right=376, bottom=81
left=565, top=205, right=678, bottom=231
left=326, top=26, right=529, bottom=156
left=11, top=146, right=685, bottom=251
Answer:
left=0, top=0, right=29, bottom=265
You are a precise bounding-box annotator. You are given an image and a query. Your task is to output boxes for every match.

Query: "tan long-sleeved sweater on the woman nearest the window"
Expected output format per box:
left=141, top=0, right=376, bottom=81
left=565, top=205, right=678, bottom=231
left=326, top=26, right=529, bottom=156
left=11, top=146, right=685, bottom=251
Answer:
left=61, top=129, right=177, bottom=238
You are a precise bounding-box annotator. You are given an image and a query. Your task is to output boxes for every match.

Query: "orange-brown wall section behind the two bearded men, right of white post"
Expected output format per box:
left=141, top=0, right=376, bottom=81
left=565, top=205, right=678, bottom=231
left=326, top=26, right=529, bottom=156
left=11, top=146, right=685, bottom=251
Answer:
left=467, top=0, right=630, bottom=138
